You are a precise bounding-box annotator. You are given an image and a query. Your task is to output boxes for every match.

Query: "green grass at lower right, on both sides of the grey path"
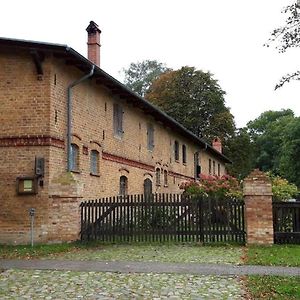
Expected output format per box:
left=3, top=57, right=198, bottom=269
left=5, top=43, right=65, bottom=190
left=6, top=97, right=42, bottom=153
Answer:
left=246, top=245, right=300, bottom=299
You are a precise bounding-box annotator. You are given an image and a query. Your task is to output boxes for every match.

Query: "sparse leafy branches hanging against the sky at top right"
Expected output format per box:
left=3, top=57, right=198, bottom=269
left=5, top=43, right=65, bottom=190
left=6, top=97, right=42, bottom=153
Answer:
left=266, top=0, right=300, bottom=90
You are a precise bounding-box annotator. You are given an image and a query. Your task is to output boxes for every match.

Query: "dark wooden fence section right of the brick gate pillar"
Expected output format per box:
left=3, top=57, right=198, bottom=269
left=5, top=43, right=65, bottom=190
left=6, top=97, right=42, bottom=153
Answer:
left=273, top=202, right=300, bottom=244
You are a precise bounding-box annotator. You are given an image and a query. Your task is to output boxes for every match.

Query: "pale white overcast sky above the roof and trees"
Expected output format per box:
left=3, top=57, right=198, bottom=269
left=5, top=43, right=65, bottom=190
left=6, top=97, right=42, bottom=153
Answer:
left=0, top=0, right=300, bottom=127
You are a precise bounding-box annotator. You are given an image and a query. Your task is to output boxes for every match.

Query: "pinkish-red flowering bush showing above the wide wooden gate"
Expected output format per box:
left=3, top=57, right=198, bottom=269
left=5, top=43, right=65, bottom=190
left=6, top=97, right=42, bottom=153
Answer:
left=180, top=174, right=242, bottom=199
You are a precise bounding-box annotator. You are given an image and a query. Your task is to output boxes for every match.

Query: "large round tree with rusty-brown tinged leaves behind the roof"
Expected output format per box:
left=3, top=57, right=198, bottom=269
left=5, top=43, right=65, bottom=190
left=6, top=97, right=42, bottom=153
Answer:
left=145, top=67, right=235, bottom=143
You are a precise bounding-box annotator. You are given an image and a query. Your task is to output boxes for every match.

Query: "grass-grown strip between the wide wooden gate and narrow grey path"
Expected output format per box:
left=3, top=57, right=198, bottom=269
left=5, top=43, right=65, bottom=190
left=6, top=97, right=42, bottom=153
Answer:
left=0, top=243, right=243, bottom=264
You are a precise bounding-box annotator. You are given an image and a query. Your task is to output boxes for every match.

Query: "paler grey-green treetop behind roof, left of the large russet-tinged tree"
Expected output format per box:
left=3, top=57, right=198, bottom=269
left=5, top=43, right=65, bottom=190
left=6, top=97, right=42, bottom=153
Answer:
left=123, top=60, right=171, bottom=97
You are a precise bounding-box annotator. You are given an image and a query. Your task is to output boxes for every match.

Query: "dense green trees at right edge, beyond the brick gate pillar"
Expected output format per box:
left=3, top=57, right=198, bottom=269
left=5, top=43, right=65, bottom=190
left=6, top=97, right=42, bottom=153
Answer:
left=247, top=109, right=300, bottom=187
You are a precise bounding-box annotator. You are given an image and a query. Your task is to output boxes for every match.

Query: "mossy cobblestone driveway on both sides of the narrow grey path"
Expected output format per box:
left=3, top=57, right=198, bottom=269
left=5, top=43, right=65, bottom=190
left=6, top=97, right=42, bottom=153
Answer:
left=0, top=245, right=248, bottom=300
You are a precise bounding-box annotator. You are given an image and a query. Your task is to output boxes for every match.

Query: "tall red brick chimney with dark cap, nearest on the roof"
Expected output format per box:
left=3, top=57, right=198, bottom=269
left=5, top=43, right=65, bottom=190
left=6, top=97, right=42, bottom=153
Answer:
left=86, top=21, right=101, bottom=67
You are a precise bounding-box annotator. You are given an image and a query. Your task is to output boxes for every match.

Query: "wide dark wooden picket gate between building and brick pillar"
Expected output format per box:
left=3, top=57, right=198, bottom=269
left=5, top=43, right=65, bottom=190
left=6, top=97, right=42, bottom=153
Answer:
left=80, top=194, right=245, bottom=244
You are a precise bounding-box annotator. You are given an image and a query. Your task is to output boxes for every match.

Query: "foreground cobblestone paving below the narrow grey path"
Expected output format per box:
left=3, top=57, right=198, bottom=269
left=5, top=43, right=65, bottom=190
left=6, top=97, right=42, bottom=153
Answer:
left=0, top=270, right=245, bottom=300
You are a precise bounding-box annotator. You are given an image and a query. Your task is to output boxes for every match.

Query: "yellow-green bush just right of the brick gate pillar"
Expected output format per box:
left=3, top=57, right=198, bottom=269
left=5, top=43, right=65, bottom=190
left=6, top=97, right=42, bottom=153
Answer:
left=268, top=173, right=298, bottom=201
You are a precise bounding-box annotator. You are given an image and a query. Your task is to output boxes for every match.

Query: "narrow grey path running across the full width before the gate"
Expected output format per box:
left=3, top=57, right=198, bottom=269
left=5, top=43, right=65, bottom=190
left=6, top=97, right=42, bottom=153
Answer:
left=0, top=259, right=300, bottom=276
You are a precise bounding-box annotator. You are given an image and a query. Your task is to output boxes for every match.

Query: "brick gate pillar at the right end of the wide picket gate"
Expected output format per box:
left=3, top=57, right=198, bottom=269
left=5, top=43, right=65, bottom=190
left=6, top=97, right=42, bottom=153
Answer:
left=243, top=169, right=274, bottom=245
